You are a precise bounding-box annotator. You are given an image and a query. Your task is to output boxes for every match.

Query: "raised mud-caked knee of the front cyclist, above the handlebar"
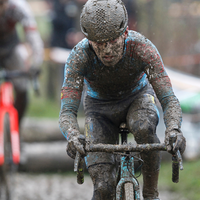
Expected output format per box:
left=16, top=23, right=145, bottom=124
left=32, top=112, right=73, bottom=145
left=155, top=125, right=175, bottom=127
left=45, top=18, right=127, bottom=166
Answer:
left=127, top=109, right=159, bottom=143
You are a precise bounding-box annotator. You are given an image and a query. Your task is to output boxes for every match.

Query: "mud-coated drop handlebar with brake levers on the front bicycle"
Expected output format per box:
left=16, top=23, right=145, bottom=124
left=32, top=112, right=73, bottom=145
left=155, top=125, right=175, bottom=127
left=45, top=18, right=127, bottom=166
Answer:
left=74, top=143, right=183, bottom=184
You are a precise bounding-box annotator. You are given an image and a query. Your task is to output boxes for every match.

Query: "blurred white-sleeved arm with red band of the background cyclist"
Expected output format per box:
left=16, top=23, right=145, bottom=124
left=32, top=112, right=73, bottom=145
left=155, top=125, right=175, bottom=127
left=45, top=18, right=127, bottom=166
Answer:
left=15, top=0, right=43, bottom=68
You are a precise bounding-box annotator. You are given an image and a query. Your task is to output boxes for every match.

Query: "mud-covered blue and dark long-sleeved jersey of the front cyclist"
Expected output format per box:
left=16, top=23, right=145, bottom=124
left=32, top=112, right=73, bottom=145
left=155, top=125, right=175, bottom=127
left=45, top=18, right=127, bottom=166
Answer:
left=60, top=31, right=182, bottom=138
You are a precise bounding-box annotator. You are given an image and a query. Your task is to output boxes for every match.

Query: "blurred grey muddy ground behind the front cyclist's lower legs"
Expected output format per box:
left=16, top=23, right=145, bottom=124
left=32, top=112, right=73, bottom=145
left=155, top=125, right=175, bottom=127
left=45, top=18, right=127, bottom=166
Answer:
left=14, top=173, right=187, bottom=200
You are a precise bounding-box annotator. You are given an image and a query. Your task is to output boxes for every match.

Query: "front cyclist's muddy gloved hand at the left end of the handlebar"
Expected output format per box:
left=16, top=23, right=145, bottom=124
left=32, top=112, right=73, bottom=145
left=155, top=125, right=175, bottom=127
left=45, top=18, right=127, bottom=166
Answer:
left=66, top=133, right=85, bottom=159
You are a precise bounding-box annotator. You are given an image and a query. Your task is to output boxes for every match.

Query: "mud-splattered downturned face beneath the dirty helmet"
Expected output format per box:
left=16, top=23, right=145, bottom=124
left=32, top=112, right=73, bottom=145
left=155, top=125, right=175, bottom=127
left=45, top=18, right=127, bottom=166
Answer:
left=90, top=34, right=125, bottom=66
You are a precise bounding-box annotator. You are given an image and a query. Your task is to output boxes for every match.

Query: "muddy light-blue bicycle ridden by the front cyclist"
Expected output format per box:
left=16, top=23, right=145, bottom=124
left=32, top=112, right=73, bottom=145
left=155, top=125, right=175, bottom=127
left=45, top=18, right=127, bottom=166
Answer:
left=74, top=124, right=183, bottom=200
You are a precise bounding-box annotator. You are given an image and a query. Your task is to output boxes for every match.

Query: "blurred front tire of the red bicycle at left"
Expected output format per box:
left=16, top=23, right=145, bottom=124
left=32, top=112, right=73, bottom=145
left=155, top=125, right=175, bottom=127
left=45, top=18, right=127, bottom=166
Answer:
left=0, top=113, right=16, bottom=200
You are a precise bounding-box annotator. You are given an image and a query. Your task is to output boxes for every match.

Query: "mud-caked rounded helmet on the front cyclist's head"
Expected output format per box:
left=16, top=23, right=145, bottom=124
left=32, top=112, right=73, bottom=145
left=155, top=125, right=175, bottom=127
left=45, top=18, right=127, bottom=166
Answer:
left=80, top=0, right=128, bottom=43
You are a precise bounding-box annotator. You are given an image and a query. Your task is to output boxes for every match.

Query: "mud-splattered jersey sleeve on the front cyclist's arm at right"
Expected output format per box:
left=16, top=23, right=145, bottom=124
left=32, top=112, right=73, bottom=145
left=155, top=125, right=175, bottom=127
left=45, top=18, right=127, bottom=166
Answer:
left=136, top=33, right=182, bottom=131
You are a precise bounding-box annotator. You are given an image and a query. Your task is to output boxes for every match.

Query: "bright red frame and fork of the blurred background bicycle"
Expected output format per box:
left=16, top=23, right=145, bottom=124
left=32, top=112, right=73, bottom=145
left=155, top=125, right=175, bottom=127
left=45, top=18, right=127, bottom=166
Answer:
left=0, top=81, right=20, bottom=165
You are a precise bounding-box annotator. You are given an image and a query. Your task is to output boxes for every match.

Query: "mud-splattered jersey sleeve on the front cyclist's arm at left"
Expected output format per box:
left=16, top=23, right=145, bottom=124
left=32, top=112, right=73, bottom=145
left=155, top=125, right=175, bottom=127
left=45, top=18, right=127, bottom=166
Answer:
left=59, top=40, right=87, bottom=139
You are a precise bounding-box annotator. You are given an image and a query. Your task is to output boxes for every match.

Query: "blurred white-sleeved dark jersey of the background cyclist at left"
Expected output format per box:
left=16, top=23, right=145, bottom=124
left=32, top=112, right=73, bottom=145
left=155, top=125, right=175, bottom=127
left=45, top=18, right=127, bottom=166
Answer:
left=0, top=0, right=43, bottom=64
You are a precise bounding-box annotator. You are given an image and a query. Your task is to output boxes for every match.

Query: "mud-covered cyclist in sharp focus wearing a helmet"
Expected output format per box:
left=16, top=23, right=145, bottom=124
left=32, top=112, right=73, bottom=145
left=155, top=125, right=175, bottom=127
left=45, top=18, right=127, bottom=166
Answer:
left=60, top=0, right=186, bottom=200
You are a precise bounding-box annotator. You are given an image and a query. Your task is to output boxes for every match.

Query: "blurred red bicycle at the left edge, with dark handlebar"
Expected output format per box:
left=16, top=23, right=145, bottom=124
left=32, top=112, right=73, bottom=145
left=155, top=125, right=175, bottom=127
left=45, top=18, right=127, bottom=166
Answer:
left=0, top=70, right=39, bottom=200
